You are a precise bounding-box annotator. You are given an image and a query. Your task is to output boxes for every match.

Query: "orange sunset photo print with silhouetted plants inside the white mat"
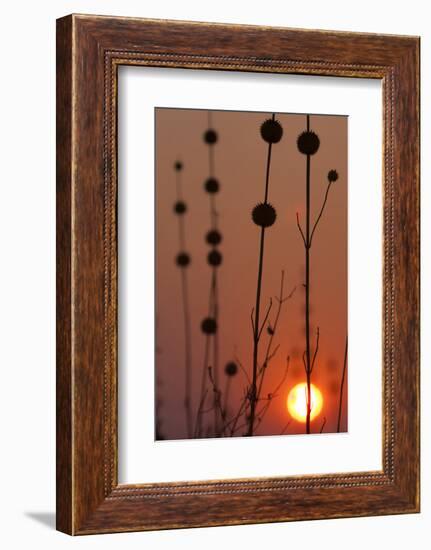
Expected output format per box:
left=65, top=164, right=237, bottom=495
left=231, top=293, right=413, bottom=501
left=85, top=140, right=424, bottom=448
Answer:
left=155, top=108, right=348, bottom=440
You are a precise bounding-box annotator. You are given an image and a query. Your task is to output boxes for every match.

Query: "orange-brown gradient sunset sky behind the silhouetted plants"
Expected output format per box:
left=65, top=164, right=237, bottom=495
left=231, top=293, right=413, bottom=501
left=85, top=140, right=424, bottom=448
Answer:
left=156, top=108, right=348, bottom=439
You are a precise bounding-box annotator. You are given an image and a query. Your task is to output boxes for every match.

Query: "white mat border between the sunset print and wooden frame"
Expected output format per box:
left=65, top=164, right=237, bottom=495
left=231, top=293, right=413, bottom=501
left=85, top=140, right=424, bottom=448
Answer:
left=118, top=66, right=383, bottom=483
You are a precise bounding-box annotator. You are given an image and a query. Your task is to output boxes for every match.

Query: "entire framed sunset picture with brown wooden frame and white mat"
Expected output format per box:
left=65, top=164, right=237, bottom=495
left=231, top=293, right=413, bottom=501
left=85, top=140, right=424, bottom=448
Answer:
left=57, top=15, right=419, bottom=535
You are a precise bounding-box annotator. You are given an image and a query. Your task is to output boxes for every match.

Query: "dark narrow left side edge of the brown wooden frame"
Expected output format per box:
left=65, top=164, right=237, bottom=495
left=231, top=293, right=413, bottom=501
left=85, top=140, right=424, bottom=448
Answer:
left=56, top=19, right=73, bottom=533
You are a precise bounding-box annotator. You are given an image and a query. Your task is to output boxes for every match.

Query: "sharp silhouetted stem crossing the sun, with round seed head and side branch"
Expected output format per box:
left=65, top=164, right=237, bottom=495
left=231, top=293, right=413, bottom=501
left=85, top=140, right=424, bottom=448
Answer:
left=296, top=115, right=338, bottom=434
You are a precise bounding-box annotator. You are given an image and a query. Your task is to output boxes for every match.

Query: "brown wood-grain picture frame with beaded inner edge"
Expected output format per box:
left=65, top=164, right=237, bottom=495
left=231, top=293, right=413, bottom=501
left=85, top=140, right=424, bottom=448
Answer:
left=57, top=15, right=419, bottom=534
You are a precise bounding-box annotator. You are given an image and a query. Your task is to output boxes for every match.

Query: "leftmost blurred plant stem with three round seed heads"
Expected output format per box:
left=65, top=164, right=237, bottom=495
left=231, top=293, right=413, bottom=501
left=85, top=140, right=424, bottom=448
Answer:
left=174, top=161, right=193, bottom=437
